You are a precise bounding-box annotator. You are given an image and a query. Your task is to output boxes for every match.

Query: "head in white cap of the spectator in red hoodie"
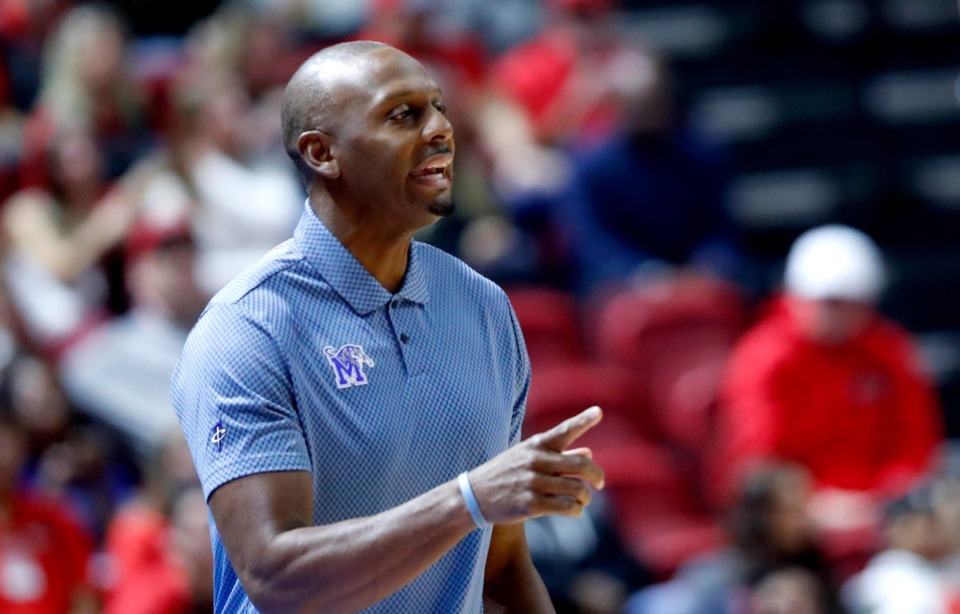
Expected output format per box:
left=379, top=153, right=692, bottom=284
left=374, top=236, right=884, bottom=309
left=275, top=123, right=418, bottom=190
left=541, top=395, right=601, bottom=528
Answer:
left=784, top=225, right=886, bottom=345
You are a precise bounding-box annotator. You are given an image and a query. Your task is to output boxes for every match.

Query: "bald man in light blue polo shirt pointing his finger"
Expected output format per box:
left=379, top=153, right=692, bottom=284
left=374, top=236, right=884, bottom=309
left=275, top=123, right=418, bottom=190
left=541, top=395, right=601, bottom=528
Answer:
left=173, top=42, right=603, bottom=613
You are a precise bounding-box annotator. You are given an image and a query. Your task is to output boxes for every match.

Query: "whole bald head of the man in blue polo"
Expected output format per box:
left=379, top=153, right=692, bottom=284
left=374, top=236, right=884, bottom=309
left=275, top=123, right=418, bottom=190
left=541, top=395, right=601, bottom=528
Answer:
left=281, top=41, right=454, bottom=229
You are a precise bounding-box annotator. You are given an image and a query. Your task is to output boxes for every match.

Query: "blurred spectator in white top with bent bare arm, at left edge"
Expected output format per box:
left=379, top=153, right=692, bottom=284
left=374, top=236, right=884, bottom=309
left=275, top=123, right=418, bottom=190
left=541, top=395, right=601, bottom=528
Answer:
left=0, top=132, right=136, bottom=358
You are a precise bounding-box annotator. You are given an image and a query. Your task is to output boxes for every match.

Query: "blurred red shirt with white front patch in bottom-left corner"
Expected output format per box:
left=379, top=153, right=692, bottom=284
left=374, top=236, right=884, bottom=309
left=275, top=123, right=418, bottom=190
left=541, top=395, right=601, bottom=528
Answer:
left=0, top=496, right=93, bottom=614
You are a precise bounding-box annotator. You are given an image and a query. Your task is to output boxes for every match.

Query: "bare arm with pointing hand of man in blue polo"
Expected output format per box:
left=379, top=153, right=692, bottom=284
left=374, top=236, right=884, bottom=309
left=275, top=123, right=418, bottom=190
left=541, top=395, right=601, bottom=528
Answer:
left=210, top=409, right=603, bottom=613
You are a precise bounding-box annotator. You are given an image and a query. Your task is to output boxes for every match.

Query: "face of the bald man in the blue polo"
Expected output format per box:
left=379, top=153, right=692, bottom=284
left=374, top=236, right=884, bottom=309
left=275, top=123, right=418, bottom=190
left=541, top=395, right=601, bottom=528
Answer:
left=330, top=49, right=454, bottom=230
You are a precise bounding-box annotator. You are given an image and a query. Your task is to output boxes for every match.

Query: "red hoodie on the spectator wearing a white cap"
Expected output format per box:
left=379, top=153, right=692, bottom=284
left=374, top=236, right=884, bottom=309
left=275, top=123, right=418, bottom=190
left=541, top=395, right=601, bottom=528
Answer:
left=720, top=304, right=943, bottom=502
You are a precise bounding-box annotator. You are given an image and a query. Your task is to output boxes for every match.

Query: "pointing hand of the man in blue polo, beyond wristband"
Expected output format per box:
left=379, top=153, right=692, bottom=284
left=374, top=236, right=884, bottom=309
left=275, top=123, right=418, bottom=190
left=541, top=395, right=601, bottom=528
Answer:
left=469, top=407, right=603, bottom=524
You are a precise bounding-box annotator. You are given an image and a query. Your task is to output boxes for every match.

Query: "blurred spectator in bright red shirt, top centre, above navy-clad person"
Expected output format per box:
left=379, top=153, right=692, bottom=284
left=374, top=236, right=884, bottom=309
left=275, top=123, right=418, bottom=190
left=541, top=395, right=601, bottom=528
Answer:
left=478, top=0, right=626, bottom=206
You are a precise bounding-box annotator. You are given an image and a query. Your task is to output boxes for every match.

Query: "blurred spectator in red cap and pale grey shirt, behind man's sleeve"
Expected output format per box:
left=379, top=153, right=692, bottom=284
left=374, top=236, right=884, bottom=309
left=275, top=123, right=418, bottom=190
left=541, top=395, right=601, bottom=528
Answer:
left=60, top=220, right=209, bottom=455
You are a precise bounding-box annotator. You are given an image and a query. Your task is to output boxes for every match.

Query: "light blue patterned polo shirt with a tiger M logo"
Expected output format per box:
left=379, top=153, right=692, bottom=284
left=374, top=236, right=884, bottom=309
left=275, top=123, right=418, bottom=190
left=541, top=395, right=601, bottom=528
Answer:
left=173, top=203, right=530, bottom=614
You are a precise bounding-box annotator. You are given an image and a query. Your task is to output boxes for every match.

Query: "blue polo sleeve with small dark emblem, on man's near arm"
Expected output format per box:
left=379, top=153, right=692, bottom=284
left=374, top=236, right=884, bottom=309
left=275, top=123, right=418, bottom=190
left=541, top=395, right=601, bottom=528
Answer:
left=171, top=304, right=310, bottom=499
